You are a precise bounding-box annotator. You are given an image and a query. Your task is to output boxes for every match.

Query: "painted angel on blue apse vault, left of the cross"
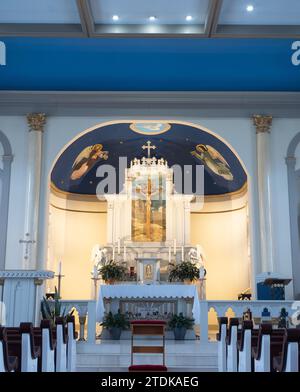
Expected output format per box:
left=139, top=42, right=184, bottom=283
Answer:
left=70, top=144, right=108, bottom=180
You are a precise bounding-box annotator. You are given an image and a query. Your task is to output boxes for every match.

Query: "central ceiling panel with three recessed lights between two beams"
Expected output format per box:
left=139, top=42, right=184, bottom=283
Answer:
left=90, top=0, right=209, bottom=24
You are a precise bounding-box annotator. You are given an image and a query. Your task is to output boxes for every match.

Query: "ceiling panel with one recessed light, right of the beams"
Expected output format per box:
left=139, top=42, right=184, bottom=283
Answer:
left=219, top=0, right=300, bottom=25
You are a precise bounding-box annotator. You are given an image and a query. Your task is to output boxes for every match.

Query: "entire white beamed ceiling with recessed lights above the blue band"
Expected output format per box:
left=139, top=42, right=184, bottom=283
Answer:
left=0, top=0, right=300, bottom=39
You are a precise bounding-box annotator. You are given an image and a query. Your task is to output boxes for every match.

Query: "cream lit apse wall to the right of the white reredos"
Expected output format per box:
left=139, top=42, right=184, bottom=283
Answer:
left=191, top=207, right=250, bottom=300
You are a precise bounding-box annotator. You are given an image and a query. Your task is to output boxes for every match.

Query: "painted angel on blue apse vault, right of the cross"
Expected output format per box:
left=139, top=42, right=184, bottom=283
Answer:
left=191, top=144, right=233, bottom=181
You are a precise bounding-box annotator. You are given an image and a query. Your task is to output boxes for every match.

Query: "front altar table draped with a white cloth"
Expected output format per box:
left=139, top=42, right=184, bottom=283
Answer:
left=97, top=284, right=200, bottom=324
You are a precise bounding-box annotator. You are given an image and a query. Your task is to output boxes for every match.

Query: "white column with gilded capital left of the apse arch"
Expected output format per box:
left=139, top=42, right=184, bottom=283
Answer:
left=20, top=113, right=46, bottom=269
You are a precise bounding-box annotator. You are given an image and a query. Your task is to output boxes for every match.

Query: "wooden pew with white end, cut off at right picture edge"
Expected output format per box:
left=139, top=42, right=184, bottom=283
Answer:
left=272, top=329, right=300, bottom=372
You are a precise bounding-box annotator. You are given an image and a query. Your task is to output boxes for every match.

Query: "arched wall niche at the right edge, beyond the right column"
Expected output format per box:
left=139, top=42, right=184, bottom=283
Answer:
left=286, top=132, right=300, bottom=299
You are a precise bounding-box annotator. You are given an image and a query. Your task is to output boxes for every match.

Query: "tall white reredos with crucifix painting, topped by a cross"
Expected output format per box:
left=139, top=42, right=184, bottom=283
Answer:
left=96, top=141, right=204, bottom=283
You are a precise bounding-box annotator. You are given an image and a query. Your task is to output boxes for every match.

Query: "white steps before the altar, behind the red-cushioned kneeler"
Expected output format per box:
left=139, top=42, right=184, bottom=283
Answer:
left=77, top=340, right=217, bottom=372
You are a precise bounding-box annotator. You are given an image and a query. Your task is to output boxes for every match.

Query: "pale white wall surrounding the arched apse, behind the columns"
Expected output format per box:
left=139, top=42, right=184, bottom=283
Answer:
left=0, top=114, right=300, bottom=300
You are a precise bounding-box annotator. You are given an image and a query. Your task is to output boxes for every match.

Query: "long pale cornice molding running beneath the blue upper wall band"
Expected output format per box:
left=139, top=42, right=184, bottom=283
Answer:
left=0, top=90, right=300, bottom=118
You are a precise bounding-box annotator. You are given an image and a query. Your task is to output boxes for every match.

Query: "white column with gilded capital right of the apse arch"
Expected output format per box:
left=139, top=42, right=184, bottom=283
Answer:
left=253, top=115, right=274, bottom=272
